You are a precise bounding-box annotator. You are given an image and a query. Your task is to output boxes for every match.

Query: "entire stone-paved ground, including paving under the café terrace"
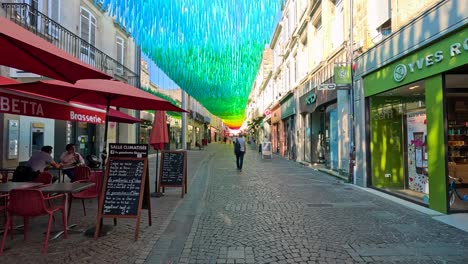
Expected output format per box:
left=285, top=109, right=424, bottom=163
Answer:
left=0, top=144, right=468, bottom=264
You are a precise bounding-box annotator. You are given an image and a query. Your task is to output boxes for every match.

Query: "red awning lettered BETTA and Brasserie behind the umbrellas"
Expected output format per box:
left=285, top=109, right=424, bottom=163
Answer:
left=0, top=76, right=141, bottom=124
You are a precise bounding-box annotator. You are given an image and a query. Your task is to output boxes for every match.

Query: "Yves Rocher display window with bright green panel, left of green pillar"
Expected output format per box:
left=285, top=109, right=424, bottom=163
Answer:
left=369, top=82, right=429, bottom=203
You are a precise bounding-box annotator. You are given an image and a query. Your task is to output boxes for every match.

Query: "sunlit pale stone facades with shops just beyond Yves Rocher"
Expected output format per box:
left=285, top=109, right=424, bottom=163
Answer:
left=252, top=0, right=352, bottom=174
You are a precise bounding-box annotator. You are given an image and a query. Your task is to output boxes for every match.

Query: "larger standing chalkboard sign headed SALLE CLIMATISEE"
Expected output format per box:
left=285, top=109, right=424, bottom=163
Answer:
left=94, top=144, right=151, bottom=240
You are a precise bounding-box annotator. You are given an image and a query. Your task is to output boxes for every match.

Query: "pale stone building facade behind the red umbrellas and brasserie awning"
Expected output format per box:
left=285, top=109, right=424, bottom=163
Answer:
left=0, top=0, right=140, bottom=168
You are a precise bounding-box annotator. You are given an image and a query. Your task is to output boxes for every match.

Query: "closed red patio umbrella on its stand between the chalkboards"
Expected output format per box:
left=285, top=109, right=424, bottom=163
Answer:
left=149, top=111, right=169, bottom=197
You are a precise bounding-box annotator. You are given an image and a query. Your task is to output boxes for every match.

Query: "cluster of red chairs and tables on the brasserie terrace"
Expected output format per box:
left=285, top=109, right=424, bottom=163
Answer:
left=0, top=166, right=102, bottom=255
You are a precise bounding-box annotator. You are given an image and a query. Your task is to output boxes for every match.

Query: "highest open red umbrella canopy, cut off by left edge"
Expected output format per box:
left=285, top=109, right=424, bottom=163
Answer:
left=0, top=17, right=112, bottom=83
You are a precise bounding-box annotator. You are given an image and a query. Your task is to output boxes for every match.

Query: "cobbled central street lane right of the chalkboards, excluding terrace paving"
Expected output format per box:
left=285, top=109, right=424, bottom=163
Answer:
left=142, top=144, right=468, bottom=263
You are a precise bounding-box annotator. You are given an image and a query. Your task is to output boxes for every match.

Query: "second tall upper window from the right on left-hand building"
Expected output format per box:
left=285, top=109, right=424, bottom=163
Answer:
left=80, top=7, right=96, bottom=65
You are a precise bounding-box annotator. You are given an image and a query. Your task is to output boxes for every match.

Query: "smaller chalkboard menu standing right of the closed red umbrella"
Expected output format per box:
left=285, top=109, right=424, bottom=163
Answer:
left=159, top=151, right=187, bottom=197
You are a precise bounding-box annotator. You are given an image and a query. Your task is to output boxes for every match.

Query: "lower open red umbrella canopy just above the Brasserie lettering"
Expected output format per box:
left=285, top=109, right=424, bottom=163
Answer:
left=0, top=79, right=186, bottom=112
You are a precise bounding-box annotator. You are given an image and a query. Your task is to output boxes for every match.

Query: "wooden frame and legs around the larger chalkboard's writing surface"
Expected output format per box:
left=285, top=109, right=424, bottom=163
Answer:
left=95, top=157, right=151, bottom=240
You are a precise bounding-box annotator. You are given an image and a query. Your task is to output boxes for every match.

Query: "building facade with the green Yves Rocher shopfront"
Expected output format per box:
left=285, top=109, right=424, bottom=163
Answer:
left=354, top=0, right=468, bottom=213
